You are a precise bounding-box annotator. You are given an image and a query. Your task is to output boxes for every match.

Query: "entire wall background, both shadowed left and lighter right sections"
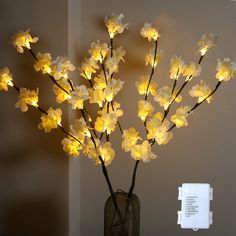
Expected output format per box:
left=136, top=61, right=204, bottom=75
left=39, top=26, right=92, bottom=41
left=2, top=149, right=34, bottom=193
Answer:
left=0, top=0, right=236, bottom=236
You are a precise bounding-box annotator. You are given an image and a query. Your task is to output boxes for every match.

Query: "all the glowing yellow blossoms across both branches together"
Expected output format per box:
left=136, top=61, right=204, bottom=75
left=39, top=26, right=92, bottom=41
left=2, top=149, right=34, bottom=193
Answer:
left=0, top=14, right=236, bottom=170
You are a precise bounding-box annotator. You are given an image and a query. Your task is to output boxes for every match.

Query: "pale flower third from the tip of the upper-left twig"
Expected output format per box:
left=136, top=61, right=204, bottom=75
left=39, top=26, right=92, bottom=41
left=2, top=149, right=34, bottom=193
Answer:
left=51, top=57, right=75, bottom=80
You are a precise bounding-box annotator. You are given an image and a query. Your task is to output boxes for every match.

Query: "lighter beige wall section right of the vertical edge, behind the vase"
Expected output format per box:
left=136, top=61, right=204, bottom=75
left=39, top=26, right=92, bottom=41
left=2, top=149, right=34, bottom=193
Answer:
left=70, top=0, right=236, bottom=236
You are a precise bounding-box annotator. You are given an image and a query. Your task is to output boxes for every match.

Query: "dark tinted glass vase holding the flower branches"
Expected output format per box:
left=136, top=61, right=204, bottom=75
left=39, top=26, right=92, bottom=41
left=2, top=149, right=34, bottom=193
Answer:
left=104, top=191, right=140, bottom=236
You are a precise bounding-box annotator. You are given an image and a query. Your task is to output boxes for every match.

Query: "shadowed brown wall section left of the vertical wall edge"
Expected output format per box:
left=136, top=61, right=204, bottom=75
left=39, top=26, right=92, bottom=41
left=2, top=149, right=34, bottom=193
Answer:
left=0, top=0, right=68, bottom=236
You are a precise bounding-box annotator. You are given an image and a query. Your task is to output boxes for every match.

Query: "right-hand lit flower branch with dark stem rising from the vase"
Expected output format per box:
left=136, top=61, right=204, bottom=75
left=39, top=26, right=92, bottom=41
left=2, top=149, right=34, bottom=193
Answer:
left=123, top=27, right=236, bottom=196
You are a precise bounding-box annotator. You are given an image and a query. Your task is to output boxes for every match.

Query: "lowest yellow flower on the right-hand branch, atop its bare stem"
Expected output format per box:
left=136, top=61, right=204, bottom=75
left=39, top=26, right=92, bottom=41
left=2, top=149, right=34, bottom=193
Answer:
left=131, top=140, right=157, bottom=162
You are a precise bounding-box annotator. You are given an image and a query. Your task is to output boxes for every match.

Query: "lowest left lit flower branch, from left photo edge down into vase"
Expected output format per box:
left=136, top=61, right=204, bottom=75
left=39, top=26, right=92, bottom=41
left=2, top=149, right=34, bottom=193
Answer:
left=0, top=67, right=121, bottom=219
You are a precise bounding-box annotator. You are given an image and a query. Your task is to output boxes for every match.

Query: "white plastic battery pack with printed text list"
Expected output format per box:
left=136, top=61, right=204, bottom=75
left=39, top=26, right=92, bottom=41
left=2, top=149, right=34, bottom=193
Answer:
left=177, top=183, right=213, bottom=231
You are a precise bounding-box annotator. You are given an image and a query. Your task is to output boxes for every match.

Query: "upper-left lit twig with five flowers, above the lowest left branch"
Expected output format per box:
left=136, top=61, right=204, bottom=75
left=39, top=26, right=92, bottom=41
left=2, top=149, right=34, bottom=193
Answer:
left=12, top=30, right=100, bottom=146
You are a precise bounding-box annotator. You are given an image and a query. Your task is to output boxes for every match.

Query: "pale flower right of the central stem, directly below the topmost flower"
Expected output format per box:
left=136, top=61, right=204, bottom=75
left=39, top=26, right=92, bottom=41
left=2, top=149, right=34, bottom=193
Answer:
left=105, top=47, right=126, bottom=76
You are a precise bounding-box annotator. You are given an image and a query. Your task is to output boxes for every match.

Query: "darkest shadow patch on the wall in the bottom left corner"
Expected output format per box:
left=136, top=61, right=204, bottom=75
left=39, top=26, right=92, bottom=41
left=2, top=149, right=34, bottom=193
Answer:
left=0, top=196, right=60, bottom=236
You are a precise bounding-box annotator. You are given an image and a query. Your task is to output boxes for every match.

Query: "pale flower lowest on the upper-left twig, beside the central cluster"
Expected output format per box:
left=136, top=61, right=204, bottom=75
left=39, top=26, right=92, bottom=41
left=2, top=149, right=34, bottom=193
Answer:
left=68, top=85, right=89, bottom=109
